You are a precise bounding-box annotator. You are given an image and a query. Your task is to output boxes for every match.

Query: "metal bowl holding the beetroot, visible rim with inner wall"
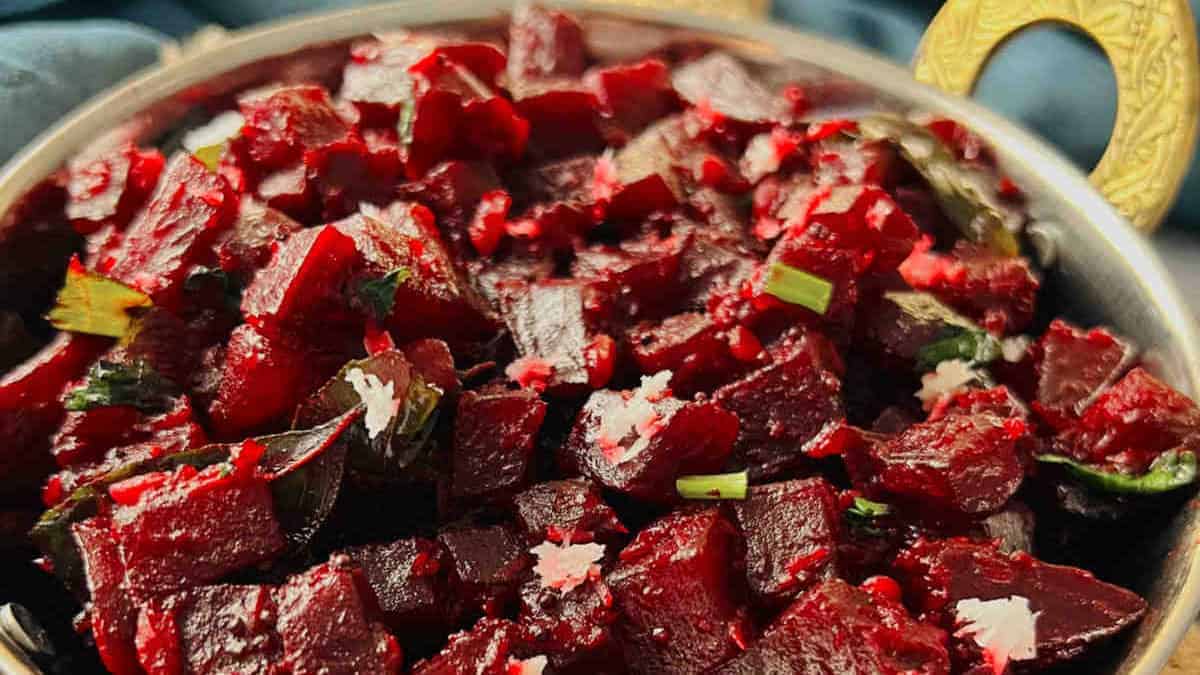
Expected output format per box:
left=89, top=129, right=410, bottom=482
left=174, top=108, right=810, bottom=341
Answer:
left=0, top=0, right=1200, bottom=675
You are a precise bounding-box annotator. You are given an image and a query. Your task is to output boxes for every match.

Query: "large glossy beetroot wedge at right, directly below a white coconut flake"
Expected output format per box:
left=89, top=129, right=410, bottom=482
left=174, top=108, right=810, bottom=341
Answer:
left=846, top=413, right=1026, bottom=515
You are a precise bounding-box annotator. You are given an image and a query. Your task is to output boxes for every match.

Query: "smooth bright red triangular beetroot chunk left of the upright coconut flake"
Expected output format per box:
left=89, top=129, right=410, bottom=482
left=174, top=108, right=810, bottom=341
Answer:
left=209, top=324, right=340, bottom=438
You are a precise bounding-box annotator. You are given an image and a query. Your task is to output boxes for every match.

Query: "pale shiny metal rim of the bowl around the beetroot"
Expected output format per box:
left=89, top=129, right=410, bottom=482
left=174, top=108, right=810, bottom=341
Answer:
left=0, top=0, right=1200, bottom=675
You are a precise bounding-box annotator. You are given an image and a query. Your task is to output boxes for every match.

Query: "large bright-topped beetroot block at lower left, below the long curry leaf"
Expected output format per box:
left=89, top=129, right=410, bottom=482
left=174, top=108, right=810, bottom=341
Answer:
left=109, top=456, right=284, bottom=595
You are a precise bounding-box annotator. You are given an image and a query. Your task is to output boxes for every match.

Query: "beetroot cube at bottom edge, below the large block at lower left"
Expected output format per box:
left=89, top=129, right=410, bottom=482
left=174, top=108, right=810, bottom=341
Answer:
left=137, top=585, right=282, bottom=675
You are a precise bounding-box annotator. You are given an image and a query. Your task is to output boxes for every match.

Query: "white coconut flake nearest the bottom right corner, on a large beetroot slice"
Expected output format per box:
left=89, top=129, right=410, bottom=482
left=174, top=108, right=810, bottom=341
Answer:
left=954, top=596, right=1042, bottom=675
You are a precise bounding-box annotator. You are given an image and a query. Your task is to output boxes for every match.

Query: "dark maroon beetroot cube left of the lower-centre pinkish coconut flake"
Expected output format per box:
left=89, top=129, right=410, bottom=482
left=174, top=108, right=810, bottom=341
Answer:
left=346, top=538, right=457, bottom=640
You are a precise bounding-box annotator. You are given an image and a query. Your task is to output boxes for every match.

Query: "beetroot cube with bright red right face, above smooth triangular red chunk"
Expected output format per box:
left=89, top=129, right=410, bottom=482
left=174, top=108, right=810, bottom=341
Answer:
left=241, top=225, right=360, bottom=336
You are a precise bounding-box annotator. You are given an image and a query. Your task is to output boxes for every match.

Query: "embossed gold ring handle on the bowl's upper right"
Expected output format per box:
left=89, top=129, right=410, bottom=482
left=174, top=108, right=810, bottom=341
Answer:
left=913, top=0, right=1200, bottom=232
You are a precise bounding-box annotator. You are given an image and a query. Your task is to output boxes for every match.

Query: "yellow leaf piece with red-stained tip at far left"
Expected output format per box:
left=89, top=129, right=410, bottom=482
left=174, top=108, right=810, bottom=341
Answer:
left=46, top=257, right=151, bottom=338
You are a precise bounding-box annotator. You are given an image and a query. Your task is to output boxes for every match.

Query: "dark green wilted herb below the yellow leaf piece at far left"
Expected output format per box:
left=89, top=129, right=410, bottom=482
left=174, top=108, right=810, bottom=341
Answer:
left=64, top=360, right=179, bottom=412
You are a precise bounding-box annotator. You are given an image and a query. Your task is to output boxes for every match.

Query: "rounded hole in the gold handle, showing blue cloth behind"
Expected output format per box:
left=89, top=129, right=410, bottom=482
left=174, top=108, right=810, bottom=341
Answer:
left=974, top=24, right=1117, bottom=172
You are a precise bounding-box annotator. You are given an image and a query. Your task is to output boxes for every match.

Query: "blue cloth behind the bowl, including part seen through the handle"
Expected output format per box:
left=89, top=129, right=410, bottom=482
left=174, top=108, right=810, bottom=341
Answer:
left=0, top=0, right=1200, bottom=228
